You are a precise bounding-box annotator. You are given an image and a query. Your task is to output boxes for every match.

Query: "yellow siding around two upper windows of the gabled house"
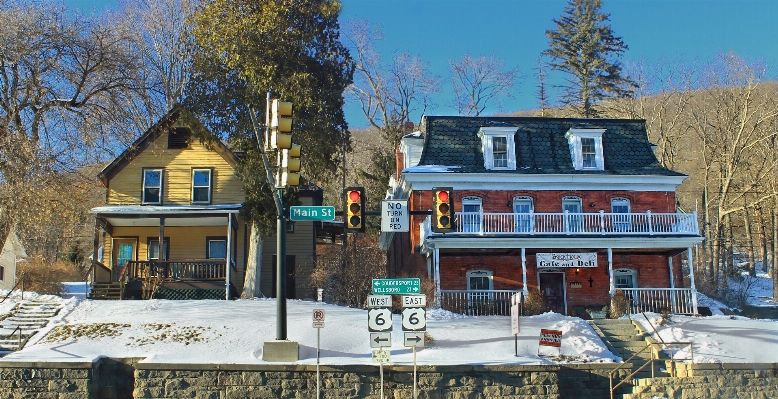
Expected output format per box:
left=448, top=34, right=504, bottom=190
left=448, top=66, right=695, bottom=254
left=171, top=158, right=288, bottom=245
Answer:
left=107, top=133, right=244, bottom=205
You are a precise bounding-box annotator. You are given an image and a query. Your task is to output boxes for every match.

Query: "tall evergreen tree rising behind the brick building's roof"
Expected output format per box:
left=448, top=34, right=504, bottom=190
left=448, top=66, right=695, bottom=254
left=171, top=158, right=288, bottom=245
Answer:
left=543, top=0, right=636, bottom=118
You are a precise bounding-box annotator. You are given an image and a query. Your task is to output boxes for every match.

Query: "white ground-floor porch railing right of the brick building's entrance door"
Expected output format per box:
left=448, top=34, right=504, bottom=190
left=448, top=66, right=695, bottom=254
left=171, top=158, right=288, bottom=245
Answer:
left=618, top=288, right=697, bottom=314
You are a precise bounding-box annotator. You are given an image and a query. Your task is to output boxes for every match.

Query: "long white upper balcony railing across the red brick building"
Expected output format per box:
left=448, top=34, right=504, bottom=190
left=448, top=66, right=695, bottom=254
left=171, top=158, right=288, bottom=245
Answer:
left=423, top=211, right=699, bottom=236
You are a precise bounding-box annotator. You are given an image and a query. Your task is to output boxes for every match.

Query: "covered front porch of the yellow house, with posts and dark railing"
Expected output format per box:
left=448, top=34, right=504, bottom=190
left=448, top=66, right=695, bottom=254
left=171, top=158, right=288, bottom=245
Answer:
left=91, top=204, right=245, bottom=299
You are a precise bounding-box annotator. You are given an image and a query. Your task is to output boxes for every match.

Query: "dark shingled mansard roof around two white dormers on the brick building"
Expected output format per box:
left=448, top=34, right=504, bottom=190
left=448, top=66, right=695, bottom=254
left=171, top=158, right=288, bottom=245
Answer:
left=419, top=116, right=685, bottom=176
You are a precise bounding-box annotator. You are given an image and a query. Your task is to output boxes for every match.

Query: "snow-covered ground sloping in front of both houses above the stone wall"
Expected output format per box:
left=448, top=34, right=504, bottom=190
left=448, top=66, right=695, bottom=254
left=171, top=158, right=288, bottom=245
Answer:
left=0, top=291, right=778, bottom=365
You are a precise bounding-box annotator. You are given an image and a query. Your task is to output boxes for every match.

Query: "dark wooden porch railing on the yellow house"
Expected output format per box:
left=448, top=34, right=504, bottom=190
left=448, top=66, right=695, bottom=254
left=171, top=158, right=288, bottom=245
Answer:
left=123, top=259, right=227, bottom=280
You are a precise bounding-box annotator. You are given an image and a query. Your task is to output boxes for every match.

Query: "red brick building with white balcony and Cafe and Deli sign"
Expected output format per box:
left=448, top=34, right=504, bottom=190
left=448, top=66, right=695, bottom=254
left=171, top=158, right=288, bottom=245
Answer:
left=381, top=116, right=702, bottom=314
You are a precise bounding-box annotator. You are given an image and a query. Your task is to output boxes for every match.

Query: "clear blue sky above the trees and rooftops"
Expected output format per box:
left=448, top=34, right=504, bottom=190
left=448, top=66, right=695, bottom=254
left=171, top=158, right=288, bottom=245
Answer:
left=65, top=0, right=778, bottom=128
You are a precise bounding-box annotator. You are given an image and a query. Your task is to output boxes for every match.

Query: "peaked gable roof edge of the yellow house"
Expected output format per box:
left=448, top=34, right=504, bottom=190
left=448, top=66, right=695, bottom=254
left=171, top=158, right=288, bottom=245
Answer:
left=97, top=105, right=238, bottom=187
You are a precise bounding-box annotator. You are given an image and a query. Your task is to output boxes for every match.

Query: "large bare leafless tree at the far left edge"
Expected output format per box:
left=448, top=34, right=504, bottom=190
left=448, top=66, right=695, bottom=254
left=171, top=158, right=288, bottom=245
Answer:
left=0, top=0, right=138, bottom=253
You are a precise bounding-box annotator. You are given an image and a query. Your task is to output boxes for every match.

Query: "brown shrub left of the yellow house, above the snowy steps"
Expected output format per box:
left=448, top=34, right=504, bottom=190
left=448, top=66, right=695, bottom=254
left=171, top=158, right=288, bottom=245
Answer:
left=17, top=257, right=84, bottom=295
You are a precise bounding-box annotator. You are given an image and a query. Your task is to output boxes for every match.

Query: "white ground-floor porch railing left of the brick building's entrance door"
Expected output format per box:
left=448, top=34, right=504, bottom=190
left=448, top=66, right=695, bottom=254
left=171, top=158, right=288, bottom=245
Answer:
left=439, top=290, right=521, bottom=316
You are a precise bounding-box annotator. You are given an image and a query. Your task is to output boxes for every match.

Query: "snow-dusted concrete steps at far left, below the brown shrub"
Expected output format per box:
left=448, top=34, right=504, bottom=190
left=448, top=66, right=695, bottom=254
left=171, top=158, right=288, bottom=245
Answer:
left=0, top=300, right=62, bottom=357
